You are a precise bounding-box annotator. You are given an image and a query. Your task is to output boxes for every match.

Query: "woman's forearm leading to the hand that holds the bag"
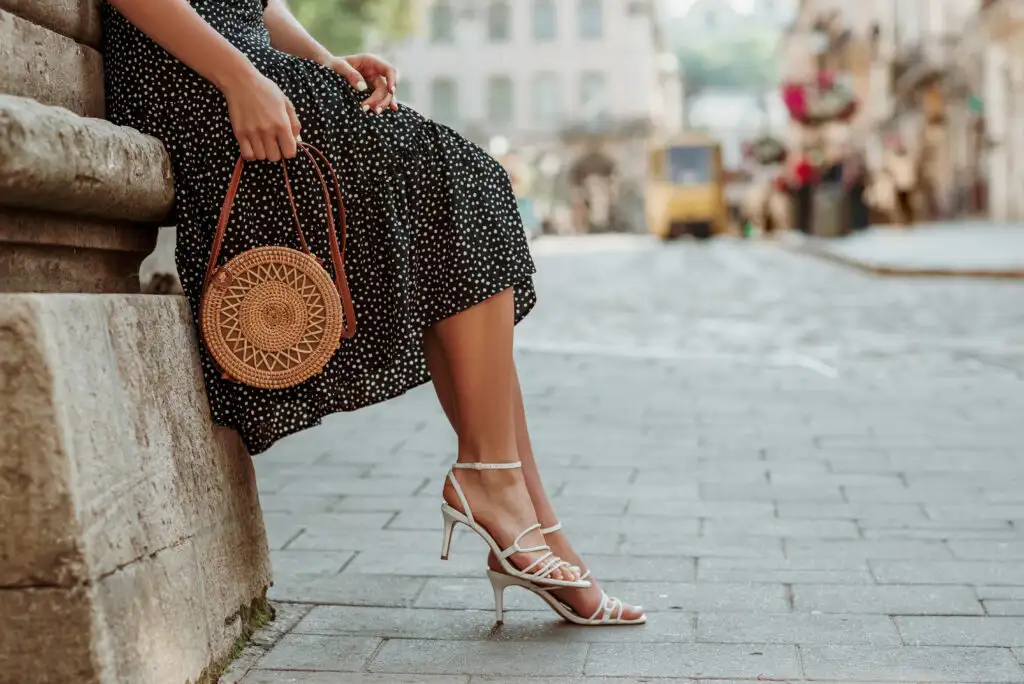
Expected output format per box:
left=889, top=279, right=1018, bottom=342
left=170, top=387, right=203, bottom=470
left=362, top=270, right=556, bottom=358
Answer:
left=109, top=0, right=256, bottom=90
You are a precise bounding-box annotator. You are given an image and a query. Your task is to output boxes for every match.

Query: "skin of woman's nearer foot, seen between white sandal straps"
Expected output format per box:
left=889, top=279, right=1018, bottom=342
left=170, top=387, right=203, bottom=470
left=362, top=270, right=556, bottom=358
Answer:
left=443, top=468, right=580, bottom=582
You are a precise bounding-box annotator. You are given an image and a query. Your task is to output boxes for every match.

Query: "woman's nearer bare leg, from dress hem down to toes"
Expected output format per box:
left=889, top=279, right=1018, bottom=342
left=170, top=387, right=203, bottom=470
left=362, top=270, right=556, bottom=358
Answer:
left=428, top=290, right=579, bottom=581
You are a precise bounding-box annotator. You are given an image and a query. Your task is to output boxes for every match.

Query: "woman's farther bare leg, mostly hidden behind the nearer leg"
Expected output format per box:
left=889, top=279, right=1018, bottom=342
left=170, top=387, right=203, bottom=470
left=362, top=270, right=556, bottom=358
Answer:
left=425, top=332, right=641, bottom=619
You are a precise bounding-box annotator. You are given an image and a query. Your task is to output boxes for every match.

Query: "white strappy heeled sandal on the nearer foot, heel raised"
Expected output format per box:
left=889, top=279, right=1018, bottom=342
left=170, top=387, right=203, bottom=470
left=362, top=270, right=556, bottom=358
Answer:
left=441, top=462, right=590, bottom=589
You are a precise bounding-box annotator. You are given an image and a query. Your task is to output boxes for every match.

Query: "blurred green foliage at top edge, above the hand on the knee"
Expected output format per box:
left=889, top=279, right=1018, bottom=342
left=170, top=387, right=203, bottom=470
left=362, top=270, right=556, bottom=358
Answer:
left=288, top=0, right=413, bottom=54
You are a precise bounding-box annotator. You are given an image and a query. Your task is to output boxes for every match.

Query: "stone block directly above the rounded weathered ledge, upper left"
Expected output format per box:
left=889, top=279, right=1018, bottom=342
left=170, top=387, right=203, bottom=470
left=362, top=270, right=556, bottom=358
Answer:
left=0, top=9, right=104, bottom=119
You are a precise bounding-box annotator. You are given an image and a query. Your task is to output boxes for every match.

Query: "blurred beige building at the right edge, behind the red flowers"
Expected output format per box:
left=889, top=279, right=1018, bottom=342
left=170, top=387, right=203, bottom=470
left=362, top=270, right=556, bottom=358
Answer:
left=779, top=0, right=1024, bottom=220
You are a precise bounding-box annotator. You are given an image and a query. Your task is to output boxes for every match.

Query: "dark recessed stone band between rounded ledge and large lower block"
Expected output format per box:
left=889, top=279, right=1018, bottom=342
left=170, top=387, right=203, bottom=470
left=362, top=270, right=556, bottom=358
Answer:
left=0, top=208, right=157, bottom=294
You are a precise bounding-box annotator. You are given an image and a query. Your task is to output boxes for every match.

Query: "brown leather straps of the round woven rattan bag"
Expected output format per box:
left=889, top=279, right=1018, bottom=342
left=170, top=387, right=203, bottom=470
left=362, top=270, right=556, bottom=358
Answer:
left=204, top=142, right=355, bottom=339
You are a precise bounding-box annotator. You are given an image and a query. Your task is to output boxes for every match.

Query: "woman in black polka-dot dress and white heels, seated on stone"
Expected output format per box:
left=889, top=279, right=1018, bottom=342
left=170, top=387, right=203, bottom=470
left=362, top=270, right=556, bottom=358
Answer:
left=103, top=0, right=643, bottom=624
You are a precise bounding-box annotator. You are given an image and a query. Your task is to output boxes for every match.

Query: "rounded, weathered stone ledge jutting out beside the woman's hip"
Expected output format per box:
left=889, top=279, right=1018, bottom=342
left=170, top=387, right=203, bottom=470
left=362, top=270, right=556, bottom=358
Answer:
left=0, top=95, right=174, bottom=222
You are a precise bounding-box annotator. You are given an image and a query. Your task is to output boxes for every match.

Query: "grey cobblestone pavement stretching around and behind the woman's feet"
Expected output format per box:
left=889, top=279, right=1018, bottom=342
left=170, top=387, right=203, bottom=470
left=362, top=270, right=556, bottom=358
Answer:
left=225, top=238, right=1024, bottom=684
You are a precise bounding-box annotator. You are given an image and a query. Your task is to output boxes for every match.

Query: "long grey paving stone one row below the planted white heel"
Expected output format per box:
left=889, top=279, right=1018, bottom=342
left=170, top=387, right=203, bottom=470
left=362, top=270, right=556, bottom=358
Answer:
left=368, top=637, right=588, bottom=676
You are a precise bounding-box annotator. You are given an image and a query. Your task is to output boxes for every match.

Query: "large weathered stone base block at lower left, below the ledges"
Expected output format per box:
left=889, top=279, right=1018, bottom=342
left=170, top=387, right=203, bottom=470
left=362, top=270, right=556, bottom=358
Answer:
left=0, top=295, right=270, bottom=684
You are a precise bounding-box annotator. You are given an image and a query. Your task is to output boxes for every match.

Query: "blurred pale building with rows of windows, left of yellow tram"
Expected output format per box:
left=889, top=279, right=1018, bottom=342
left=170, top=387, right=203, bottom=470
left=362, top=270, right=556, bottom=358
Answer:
left=387, top=0, right=683, bottom=229
